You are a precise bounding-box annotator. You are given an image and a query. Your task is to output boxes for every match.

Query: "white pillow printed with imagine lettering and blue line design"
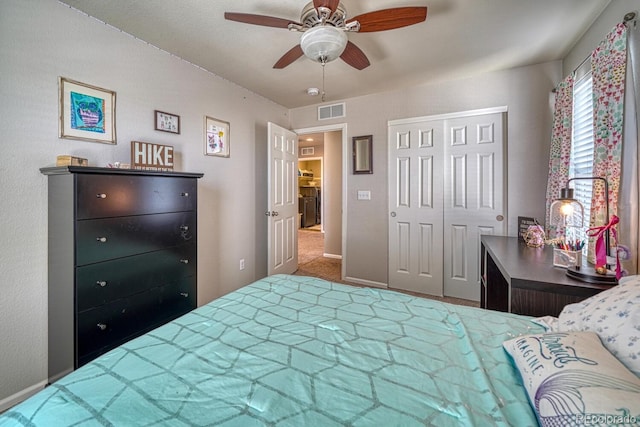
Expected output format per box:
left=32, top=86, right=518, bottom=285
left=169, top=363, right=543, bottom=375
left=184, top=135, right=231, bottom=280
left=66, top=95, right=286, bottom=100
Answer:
left=503, top=332, right=640, bottom=426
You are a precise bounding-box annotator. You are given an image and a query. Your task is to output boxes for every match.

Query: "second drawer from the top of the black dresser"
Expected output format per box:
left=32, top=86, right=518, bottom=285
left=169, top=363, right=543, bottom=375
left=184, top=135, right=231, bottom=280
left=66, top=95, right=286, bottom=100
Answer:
left=76, top=212, right=197, bottom=266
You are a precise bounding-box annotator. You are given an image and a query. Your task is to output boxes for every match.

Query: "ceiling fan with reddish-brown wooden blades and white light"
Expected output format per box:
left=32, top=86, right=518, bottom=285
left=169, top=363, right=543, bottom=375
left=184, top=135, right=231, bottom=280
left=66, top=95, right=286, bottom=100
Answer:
left=224, top=0, right=427, bottom=70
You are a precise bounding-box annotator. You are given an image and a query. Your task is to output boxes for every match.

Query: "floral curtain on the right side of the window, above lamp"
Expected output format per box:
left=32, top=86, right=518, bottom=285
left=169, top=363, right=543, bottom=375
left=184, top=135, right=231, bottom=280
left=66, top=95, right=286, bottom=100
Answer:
left=589, top=23, right=627, bottom=258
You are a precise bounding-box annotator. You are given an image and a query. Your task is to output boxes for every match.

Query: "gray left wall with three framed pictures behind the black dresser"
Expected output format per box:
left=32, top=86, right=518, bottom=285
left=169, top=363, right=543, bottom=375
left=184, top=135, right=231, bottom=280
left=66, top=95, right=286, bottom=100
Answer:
left=0, top=0, right=289, bottom=408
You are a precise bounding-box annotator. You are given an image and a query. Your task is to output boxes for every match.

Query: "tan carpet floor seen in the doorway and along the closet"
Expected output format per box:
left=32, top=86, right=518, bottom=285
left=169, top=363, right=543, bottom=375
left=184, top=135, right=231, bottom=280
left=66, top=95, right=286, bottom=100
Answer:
left=294, top=229, right=479, bottom=307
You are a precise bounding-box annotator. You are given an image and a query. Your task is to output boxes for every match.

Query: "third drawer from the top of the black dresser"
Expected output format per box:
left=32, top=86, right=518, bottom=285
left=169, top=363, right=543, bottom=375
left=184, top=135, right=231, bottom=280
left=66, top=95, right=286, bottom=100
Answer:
left=76, top=243, right=196, bottom=312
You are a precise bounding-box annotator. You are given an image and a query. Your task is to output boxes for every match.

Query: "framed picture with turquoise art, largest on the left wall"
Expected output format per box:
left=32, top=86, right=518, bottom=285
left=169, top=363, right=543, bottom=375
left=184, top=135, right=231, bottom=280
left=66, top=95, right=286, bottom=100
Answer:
left=59, top=77, right=116, bottom=144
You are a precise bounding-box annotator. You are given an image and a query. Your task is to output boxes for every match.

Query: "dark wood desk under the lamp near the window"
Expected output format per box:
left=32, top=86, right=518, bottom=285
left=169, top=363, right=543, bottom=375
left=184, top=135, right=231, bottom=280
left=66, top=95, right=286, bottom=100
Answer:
left=480, top=235, right=611, bottom=317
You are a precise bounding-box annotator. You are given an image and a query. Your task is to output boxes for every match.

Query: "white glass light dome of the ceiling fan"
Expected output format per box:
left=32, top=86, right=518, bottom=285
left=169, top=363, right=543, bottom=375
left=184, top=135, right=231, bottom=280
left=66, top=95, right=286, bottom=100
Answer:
left=300, top=25, right=348, bottom=63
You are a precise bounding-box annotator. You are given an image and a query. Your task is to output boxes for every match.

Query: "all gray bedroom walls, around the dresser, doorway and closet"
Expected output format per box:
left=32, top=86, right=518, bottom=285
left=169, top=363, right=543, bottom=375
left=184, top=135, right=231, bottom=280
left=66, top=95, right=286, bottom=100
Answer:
left=0, top=0, right=638, bottom=407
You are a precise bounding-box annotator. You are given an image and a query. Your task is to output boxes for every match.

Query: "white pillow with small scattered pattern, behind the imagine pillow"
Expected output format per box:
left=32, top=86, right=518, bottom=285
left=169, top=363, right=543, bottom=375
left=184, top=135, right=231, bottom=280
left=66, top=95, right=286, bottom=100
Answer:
left=547, top=276, right=640, bottom=376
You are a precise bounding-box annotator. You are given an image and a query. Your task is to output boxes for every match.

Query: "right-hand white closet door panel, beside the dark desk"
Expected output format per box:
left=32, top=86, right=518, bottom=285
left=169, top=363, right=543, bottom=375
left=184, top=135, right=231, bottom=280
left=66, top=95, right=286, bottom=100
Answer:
left=444, top=112, right=507, bottom=301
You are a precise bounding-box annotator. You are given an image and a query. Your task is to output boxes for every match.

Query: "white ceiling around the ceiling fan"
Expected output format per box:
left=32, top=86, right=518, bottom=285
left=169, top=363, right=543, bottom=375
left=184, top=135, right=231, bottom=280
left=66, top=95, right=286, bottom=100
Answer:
left=57, top=0, right=610, bottom=108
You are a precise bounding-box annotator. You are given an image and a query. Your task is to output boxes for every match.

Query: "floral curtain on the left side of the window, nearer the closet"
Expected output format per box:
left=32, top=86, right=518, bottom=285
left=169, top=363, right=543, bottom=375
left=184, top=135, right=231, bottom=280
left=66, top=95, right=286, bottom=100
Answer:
left=546, top=74, right=573, bottom=238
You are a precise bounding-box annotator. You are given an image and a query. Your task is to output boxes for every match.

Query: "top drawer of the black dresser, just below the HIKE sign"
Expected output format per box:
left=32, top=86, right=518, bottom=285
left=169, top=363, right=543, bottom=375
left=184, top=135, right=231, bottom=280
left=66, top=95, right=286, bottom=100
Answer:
left=76, top=174, right=197, bottom=219
